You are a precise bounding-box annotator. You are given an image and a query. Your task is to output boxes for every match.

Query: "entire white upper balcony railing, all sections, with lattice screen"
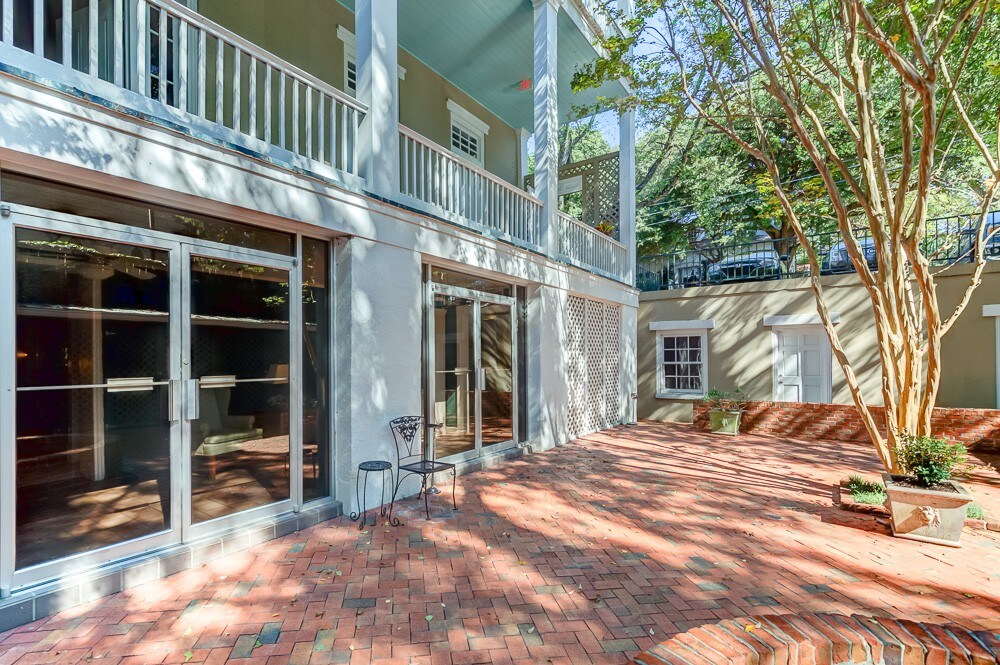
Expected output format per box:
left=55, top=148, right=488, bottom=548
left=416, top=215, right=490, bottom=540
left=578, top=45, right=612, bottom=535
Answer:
left=0, top=0, right=628, bottom=280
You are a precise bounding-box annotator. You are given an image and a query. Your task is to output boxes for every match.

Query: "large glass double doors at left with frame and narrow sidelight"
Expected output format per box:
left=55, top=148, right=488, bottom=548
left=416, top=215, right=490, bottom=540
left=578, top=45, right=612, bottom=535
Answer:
left=0, top=205, right=316, bottom=588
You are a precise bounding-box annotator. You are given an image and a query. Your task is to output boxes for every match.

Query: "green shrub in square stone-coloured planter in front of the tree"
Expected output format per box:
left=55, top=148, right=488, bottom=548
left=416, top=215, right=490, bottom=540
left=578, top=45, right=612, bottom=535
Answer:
left=882, top=435, right=972, bottom=547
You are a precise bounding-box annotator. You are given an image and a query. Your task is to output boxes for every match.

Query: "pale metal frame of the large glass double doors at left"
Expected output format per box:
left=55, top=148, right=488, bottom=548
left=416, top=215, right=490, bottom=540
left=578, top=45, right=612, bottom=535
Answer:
left=0, top=204, right=304, bottom=598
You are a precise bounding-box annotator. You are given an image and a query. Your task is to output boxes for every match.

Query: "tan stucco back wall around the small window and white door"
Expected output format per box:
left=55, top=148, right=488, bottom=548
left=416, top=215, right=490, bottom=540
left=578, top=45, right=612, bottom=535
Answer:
left=638, top=263, right=1000, bottom=421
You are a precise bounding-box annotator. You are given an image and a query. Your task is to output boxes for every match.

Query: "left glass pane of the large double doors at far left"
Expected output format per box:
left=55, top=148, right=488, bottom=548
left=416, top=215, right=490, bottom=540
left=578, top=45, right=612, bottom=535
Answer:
left=15, top=228, right=174, bottom=570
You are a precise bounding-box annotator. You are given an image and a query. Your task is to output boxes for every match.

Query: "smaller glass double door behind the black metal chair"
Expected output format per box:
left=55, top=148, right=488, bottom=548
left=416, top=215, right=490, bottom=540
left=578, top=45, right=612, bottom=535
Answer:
left=425, top=284, right=517, bottom=460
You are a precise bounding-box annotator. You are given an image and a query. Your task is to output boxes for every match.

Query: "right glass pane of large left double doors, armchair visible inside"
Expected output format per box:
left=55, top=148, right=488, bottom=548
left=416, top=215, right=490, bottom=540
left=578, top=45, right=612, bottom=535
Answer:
left=188, top=256, right=291, bottom=523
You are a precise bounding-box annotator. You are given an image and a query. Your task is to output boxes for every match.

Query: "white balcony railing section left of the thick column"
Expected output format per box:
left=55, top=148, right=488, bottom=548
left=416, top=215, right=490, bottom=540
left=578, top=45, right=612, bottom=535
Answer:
left=2, top=0, right=365, bottom=175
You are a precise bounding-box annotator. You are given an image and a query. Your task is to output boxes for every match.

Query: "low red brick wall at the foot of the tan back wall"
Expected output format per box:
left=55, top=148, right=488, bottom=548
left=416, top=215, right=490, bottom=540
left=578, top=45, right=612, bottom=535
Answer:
left=694, top=402, right=1000, bottom=450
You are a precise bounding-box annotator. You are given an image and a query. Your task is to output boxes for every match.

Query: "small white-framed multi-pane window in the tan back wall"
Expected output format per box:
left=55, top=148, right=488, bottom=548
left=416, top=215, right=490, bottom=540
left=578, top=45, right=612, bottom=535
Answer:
left=649, top=320, right=715, bottom=399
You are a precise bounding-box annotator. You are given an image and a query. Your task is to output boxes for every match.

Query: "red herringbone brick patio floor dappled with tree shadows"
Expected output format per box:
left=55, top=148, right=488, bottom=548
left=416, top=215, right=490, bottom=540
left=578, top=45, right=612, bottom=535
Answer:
left=0, top=423, right=1000, bottom=665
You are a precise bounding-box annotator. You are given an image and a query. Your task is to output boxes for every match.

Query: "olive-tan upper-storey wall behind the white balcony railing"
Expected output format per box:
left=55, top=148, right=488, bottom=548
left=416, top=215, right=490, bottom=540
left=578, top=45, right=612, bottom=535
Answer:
left=198, top=0, right=520, bottom=183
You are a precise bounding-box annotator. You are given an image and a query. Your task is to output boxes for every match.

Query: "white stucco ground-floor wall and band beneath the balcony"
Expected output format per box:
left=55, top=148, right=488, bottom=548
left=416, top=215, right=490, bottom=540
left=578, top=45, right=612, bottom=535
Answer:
left=0, top=75, right=638, bottom=512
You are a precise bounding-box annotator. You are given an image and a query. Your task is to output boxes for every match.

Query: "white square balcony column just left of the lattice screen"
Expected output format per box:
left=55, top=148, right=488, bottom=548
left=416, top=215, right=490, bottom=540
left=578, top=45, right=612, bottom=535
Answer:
left=534, top=0, right=562, bottom=256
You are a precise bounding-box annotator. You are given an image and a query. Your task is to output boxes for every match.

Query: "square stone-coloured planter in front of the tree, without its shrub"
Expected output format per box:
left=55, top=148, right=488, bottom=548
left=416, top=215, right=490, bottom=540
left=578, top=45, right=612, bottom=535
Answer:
left=882, top=473, right=972, bottom=547
